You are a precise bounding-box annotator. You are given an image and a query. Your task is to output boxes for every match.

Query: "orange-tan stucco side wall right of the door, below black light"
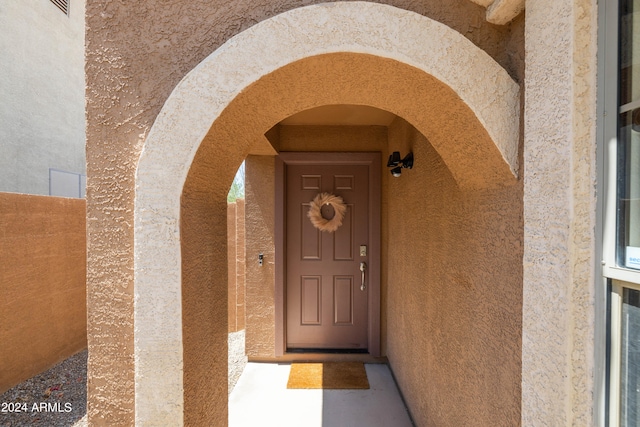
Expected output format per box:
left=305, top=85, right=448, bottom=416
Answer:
left=385, top=119, right=523, bottom=426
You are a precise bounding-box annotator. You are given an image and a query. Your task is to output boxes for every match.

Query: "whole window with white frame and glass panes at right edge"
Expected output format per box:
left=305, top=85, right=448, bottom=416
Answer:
left=601, top=0, right=640, bottom=427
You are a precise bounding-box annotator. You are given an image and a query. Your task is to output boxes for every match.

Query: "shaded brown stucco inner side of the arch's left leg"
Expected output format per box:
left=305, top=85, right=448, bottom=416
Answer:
left=180, top=182, right=230, bottom=426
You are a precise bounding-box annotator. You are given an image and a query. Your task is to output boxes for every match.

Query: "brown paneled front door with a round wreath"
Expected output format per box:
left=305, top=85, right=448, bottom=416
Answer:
left=285, top=153, right=379, bottom=350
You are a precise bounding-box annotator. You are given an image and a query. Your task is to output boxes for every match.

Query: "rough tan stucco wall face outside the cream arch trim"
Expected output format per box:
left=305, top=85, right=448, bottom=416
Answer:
left=86, top=0, right=517, bottom=425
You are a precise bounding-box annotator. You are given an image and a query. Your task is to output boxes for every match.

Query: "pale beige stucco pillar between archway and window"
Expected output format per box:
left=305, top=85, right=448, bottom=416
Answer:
left=522, top=0, right=596, bottom=426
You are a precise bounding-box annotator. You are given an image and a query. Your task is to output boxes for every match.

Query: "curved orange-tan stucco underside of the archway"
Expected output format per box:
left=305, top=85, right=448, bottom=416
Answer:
left=204, top=52, right=514, bottom=188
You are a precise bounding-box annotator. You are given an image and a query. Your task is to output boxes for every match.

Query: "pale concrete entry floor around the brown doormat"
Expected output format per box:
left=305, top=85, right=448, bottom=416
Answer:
left=229, top=363, right=413, bottom=427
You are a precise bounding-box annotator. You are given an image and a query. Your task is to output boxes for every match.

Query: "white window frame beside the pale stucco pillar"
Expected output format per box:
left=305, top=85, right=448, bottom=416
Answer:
left=594, top=0, right=640, bottom=427
